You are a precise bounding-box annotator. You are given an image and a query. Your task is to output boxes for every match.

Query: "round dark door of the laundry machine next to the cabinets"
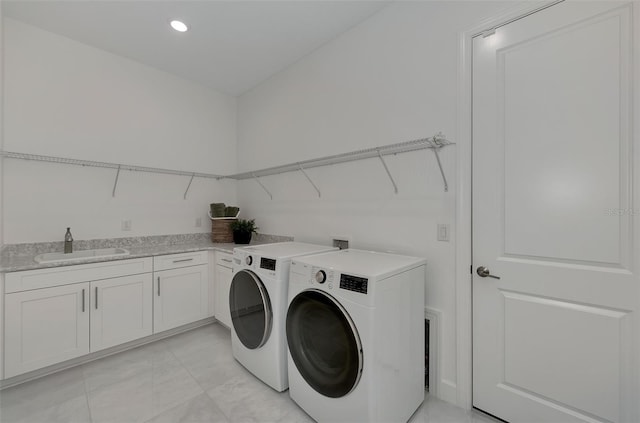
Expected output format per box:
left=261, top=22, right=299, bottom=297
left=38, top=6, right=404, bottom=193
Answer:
left=229, top=270, right=273, bottom=350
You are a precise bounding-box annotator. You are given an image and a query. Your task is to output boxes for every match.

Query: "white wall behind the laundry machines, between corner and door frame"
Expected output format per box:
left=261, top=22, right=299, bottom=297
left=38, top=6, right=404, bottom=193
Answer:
left=237, top=2, right=505, bottom=402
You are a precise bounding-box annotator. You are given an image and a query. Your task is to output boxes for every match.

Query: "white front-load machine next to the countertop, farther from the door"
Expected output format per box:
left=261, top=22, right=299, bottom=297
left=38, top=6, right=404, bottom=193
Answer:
left=229, top=242, right=336, bottom=392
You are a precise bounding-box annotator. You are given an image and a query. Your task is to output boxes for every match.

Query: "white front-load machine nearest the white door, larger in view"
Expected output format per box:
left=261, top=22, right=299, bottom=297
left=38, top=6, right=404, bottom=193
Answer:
left=286, top=250, right=426, bottom=422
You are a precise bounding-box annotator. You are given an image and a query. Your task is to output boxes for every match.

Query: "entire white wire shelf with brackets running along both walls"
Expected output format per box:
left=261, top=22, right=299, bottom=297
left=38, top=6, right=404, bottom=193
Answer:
left=0, top=134, right=454, bottom=199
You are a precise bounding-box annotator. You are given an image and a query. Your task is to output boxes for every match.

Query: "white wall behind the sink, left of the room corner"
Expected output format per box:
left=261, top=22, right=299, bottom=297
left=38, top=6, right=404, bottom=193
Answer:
left=3, top=18, right=236, bottom=244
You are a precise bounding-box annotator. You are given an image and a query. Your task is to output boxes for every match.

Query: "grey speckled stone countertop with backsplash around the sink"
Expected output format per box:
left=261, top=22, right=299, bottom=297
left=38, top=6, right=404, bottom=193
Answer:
left=0, top=234, right=293, bottom=273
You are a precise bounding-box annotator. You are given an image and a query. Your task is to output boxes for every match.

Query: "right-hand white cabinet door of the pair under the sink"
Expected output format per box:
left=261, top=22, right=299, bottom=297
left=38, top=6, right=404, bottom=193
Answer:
left=90, top=273, right=153, bottom=352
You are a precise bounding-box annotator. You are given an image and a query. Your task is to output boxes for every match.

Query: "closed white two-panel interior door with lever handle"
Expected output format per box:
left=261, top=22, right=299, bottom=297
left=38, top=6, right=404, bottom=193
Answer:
left=473, top=2, right=640, bottom=422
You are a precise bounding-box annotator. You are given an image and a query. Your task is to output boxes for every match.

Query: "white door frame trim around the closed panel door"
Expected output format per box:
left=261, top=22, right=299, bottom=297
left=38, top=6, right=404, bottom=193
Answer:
left=455, top=0, right=640, bottom=409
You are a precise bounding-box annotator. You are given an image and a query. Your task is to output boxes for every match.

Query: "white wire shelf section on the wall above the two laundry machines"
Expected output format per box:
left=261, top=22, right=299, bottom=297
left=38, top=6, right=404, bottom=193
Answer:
left=224, top=133, right=455, bottom=191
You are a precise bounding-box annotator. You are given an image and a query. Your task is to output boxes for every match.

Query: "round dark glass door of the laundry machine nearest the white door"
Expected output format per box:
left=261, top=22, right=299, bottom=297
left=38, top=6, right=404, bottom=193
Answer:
left=287, top=289, right=362, bottom=398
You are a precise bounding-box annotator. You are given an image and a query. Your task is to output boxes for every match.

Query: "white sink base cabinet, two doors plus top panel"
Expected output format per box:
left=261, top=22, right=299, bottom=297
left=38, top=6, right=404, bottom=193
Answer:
left=4, top=258, right=153, bottom=378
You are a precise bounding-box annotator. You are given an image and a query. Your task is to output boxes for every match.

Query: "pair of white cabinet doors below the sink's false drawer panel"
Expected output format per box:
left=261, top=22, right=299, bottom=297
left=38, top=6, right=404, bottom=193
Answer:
left=5, top=273, right=152, bottom=377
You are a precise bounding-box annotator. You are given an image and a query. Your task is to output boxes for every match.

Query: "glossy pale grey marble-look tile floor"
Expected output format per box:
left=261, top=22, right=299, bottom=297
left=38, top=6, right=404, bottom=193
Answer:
left=0, top=324, right=495, bottom=423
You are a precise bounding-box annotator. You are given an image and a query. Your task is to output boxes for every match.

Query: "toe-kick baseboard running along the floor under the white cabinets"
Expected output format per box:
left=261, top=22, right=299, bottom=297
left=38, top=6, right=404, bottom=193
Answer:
left=0, top=317, right=216, bottom=390
